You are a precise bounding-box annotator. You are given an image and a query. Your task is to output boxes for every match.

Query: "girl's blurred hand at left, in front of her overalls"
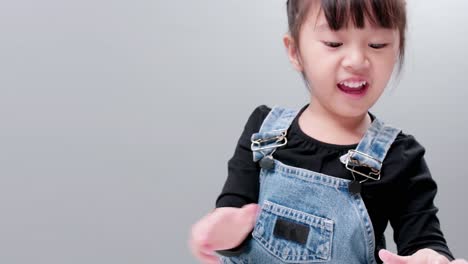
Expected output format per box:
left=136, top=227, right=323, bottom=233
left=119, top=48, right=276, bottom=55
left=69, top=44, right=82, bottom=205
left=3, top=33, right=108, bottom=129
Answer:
left=189, top=204, right=259, bottom=264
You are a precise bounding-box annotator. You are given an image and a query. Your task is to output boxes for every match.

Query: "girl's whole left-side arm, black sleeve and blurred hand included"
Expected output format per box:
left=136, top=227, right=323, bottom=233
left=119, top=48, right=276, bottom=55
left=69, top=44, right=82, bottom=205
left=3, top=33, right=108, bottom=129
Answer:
left=189, top=106, right=270, bottom=264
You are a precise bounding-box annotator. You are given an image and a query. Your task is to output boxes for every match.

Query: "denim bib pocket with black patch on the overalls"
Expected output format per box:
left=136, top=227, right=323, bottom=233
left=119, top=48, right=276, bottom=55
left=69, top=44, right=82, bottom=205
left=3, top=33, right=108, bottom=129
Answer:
left=252, top=200, right=334, bottom=263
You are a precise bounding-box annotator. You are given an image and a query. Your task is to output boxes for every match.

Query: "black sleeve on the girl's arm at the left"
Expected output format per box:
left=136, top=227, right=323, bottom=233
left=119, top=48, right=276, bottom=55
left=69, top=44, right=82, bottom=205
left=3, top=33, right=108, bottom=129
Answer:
left=216, top=105, right=271, bottom=256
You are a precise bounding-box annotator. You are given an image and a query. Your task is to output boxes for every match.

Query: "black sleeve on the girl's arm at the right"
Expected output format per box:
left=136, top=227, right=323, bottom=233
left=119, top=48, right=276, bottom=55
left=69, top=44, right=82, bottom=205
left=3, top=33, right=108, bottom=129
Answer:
left=390, top=136, right=453, bottom=260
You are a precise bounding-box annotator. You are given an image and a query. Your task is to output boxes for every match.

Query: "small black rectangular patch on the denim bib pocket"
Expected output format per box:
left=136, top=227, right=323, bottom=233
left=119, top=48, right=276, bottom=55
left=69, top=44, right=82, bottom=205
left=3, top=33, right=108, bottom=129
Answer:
left=273, top=218, right=309, bottom=245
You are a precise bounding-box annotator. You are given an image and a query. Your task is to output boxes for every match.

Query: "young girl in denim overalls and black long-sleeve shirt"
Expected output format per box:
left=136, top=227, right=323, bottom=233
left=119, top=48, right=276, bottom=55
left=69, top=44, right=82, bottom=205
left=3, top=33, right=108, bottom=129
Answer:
left=190, top=0, right=467, bottom=264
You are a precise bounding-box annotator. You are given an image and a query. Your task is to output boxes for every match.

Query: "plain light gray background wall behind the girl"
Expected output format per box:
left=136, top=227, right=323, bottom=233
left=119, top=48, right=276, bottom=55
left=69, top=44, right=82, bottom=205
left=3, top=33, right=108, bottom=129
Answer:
left=0, top=0, right=468, bottom=264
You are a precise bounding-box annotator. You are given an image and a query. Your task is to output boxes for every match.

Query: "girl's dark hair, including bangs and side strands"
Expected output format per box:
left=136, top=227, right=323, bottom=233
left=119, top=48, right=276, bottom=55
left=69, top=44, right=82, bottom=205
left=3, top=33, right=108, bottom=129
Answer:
left=286, top=0, right=406, bottom=67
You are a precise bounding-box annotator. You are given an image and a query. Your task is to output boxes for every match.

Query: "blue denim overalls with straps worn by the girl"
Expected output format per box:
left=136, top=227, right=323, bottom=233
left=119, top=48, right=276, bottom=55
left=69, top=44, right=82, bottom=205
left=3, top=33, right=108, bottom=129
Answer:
left=221, top=107, right=400, bottom=264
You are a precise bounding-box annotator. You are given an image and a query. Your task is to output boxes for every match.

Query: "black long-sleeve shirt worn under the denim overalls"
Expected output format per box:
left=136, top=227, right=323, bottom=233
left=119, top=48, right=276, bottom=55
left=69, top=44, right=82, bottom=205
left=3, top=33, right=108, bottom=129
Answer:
left=216, top=105, right=453, bottom=261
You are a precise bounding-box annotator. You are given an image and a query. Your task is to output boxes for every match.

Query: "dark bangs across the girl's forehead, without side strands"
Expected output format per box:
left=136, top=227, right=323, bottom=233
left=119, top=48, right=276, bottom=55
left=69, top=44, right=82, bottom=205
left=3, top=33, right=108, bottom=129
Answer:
left=321, top=0, right=406, bottom=30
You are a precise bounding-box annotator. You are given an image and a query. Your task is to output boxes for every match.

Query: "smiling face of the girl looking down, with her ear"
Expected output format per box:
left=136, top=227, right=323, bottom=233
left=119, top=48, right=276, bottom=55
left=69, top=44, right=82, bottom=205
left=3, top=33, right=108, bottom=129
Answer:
left=284, top=1, right=399, bottom=117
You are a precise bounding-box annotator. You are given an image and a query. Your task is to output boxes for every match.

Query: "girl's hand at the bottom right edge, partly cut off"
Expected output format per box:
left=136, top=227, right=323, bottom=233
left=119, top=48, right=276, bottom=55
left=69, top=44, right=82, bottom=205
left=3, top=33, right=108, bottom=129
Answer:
left=379, top=248, right=452, bottom=264
